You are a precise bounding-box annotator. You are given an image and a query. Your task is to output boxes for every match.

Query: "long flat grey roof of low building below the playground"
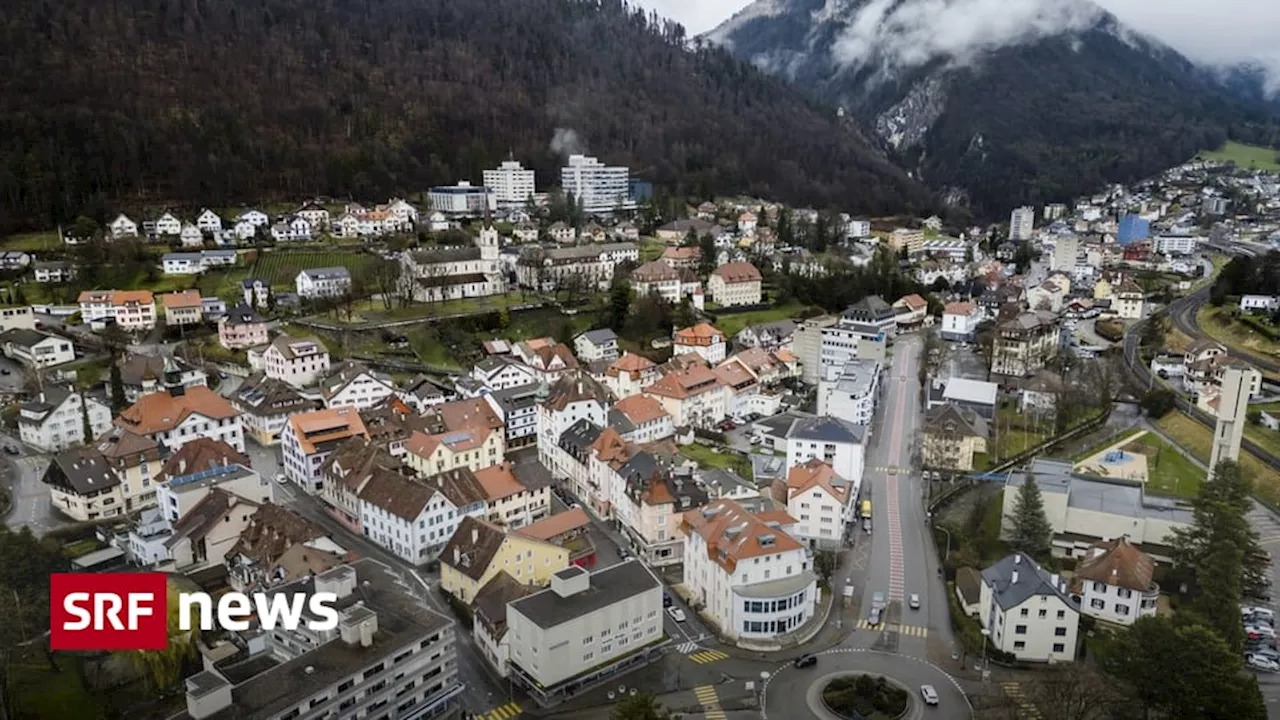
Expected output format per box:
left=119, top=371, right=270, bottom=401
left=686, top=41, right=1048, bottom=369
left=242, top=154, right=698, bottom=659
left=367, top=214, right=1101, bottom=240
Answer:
left=1007, top=459, right=1193, bottom=525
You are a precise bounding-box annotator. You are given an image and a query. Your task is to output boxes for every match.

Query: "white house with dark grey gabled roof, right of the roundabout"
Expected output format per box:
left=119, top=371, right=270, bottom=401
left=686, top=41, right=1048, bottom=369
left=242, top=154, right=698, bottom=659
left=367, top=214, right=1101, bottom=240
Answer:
left=978, top=553, right=1080, bottom=662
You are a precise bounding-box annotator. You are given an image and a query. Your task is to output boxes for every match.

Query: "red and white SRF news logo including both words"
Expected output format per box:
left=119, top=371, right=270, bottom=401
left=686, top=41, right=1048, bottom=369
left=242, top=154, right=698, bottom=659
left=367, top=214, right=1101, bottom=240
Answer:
left=49, top=573, right=338, bottom=651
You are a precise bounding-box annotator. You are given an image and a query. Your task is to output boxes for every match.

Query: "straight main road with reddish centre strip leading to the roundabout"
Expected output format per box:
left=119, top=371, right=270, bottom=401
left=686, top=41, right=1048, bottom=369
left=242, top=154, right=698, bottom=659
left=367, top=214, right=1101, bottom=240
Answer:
left=855, top=336, right=955, bottom=659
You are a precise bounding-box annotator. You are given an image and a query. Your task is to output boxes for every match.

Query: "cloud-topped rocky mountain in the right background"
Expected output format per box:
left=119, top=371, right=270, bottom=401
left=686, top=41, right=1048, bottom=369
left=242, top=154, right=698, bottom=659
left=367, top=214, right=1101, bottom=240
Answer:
left=707, top=0, right=1277, bottom=217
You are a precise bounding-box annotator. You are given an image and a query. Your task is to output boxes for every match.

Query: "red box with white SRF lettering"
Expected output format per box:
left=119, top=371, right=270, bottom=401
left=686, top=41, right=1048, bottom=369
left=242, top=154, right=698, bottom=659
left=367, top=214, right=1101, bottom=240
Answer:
left=49, top=573, right=169, bottom=651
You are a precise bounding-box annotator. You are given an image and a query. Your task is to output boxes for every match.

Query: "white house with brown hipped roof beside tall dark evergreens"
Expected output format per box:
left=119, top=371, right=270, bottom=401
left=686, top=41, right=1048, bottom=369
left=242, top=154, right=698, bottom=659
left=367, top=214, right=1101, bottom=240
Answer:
left=1071, top=536, right=1160, bottom=625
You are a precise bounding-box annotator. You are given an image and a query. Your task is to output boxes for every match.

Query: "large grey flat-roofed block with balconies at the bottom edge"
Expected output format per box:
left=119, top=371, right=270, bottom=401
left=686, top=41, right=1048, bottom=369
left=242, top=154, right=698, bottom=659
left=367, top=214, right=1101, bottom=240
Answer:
left=175, top=557, right=463, bottom=720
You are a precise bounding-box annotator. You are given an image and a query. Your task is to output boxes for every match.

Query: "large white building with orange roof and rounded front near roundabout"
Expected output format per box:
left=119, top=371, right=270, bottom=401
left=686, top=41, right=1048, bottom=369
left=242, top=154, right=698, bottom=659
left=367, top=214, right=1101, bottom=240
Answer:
left=682, top=498, right=818, bottom=641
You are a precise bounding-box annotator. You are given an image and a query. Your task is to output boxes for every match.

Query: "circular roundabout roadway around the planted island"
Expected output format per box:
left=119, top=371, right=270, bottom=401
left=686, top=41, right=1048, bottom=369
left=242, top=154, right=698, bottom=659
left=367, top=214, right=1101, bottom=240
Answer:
left=760, top=648, right=973, bottom=720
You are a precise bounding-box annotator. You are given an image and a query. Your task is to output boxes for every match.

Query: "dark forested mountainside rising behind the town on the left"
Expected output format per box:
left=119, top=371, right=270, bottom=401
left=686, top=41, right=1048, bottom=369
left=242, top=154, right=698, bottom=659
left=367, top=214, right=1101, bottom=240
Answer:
left=0, top=0, right=933, bottom=232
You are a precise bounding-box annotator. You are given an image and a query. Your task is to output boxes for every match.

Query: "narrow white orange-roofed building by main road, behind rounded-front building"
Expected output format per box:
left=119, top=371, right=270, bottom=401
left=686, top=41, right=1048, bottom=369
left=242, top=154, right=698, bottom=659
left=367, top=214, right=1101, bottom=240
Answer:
left=780, top=460, right=860, bottom=550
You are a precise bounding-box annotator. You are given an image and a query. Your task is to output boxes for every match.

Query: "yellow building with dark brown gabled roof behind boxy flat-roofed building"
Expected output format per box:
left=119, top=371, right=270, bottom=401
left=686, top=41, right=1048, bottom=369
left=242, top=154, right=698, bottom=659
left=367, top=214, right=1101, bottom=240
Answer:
left=440, top=516, right=570, bottom=605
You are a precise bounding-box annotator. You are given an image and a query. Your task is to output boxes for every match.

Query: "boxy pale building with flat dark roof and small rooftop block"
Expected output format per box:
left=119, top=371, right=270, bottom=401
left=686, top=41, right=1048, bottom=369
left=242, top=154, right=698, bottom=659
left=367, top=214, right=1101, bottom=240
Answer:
left=507, top=560, right=663, bottom=696
